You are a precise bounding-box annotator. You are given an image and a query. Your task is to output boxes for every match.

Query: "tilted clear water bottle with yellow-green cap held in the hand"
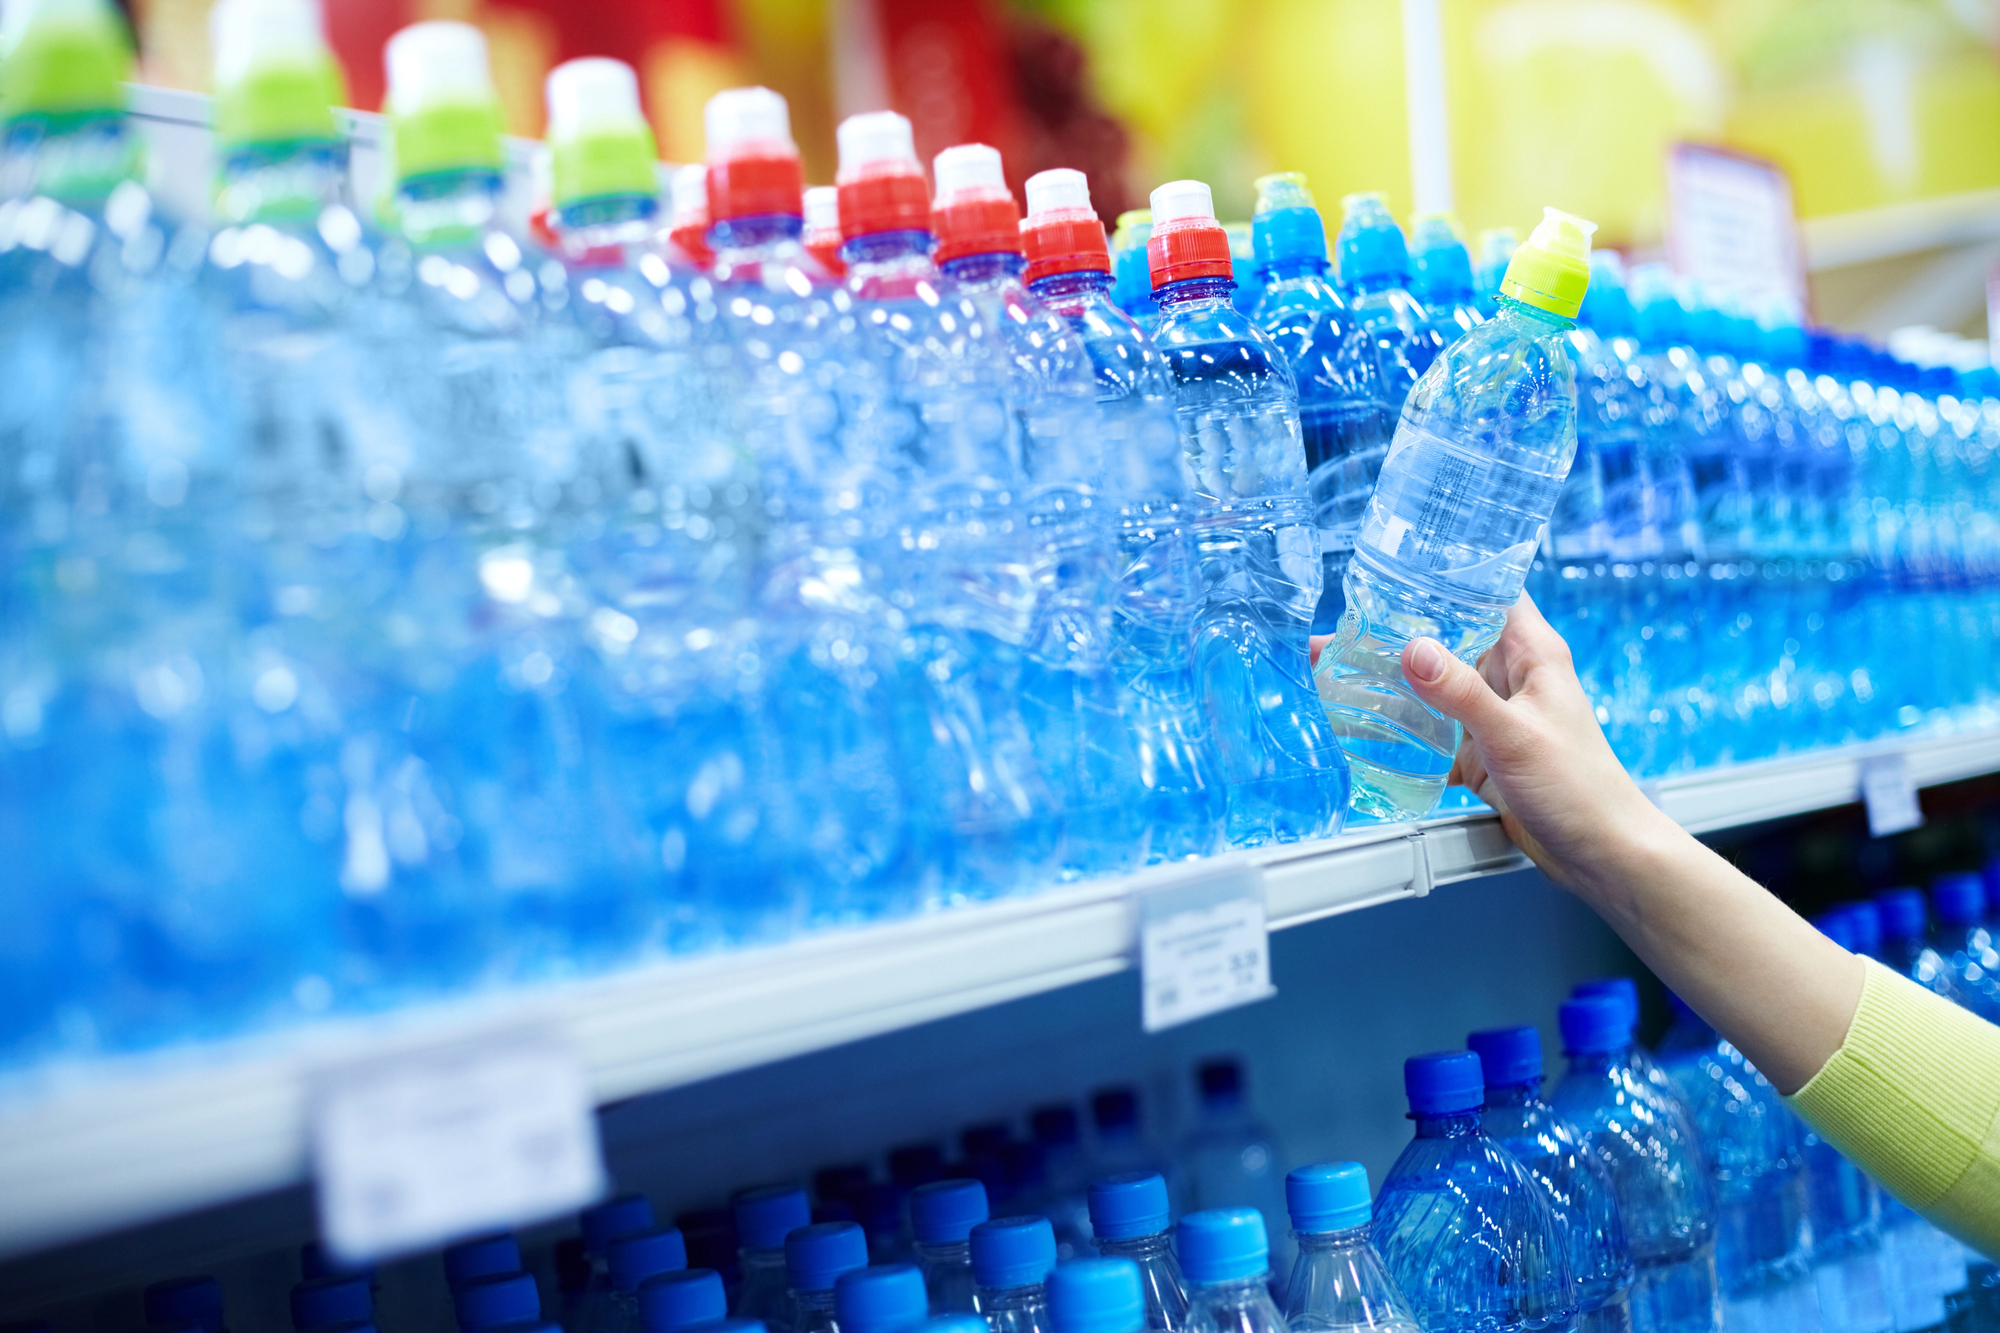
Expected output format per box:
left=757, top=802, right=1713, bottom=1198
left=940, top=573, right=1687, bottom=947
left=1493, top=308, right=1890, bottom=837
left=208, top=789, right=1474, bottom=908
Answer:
left=1316, top=208, right=1594, bottom=819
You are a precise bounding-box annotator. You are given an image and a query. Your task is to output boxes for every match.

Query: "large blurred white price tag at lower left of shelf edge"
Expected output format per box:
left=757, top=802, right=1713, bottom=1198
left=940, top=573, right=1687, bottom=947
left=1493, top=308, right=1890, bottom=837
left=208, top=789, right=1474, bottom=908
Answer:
left=312, top=1033, right=604, bottom=1263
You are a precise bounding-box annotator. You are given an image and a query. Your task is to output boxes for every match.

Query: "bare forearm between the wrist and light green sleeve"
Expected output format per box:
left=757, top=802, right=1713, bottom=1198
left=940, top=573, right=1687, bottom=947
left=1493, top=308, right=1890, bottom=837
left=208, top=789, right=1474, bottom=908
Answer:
left=1568, top=807, right=1864, bottom=1095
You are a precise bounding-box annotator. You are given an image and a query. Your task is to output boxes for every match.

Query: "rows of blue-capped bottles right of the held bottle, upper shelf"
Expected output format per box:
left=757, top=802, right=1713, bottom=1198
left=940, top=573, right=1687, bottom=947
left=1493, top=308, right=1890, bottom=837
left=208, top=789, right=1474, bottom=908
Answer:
left=1530, top=254, right=2000, bottom=775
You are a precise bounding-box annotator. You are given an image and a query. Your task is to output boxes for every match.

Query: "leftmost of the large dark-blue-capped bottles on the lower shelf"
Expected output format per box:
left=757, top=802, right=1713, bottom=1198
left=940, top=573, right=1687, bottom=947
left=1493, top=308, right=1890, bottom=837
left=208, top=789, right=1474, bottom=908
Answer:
left=1372, top=1051, right=1576, bottom=1333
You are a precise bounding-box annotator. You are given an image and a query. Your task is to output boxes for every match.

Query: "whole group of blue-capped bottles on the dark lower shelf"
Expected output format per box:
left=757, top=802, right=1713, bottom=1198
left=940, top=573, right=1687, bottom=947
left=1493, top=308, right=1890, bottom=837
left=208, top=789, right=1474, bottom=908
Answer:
left=129, top=912, right=2000, bottom=1333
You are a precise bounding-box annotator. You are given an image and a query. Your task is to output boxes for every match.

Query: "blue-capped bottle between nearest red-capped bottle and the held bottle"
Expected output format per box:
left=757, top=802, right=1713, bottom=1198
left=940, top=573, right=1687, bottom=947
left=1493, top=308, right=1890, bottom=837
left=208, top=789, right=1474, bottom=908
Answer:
left=1252, top=172, right=1402, bottom=634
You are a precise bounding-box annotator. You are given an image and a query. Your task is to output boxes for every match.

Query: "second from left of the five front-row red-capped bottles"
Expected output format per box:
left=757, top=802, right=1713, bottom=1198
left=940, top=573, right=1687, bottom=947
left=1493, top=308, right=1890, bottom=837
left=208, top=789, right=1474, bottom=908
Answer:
left=838, top=112, right=1062, bottom=901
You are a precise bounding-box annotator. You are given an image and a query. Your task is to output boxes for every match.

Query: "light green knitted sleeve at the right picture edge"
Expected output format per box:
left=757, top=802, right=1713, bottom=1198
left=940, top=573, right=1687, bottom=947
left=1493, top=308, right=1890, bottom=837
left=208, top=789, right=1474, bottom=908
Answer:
left=1790, top=961, right=2000, bottom=1255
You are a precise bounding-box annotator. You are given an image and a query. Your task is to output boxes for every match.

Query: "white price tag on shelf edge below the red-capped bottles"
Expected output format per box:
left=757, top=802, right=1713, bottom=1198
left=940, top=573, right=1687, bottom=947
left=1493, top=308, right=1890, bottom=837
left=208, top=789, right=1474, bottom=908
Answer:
left=1138, top=867, right=1276, bottom=1033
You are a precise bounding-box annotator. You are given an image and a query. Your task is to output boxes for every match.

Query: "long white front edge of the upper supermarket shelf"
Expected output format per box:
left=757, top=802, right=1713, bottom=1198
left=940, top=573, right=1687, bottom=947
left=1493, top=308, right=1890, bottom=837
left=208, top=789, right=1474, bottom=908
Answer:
left=0, top=729, right=2000, bottom=1257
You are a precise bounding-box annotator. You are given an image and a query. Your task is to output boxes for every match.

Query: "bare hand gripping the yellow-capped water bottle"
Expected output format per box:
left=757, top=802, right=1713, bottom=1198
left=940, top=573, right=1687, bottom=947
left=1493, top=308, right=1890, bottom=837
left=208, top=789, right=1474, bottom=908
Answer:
left=1402, top=594, right=1686, bottom=899
